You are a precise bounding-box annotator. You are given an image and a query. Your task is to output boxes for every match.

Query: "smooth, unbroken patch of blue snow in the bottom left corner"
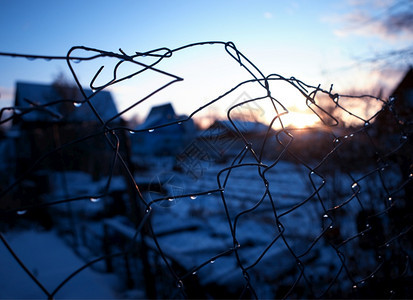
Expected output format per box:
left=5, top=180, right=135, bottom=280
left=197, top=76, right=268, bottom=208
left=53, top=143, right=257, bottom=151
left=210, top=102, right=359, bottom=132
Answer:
left=0, top=230, right=120, bottom=299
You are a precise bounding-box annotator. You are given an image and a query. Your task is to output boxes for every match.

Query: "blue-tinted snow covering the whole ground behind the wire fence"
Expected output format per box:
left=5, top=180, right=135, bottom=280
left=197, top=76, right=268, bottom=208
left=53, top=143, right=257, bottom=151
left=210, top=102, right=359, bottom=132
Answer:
left=0, top=158, right=406, bottom=298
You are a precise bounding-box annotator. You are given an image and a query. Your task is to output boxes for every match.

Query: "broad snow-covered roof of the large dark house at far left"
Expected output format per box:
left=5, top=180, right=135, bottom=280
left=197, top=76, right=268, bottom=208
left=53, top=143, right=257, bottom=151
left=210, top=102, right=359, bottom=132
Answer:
left=15, top=82, right=119, bottom=122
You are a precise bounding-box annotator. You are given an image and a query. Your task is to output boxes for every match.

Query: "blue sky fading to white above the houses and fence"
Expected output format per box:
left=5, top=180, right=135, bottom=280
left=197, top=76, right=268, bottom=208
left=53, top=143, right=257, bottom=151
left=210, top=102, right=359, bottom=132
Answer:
left=0, top=0, right=412, bottom=125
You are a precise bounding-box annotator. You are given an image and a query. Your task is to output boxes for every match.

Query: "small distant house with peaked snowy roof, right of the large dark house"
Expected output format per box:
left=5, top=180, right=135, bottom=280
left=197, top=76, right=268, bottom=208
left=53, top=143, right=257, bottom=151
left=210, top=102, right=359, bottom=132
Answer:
left=131, top=103, right=196, bottom=157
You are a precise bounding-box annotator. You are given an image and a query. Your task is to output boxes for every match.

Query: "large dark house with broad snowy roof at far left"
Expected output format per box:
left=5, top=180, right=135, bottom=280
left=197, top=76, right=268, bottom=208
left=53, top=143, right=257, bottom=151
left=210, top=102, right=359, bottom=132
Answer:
left=12, top=82, right=121, bottom=179
